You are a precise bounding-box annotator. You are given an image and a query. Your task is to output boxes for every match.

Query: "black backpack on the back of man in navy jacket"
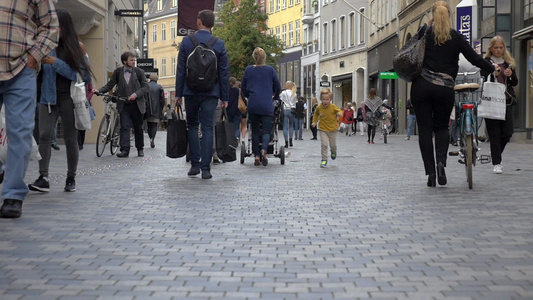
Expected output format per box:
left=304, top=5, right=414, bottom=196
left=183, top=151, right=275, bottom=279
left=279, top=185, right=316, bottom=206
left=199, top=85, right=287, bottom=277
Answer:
left=186, top=35, right=218, bottom=92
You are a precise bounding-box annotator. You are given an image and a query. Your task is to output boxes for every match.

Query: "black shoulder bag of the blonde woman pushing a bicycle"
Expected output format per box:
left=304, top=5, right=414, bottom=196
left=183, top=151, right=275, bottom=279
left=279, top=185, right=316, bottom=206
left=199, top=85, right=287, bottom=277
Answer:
left=392, top=25, right=429, bottom=82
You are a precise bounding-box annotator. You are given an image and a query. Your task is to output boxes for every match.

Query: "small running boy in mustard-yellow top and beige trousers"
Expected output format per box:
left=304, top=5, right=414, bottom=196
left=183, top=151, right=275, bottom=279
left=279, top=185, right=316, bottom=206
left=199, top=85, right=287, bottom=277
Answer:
left=311, top=89, right=342, bottom=168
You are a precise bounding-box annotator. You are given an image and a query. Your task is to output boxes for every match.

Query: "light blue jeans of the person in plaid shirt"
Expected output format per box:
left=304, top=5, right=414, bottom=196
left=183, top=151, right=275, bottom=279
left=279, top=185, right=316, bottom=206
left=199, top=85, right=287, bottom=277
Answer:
left=0, top=68, right=37, bottom=200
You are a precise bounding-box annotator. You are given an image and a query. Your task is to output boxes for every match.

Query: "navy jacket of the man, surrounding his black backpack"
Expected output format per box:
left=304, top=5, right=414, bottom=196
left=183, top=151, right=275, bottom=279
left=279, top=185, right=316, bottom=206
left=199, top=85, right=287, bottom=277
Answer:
left=176, top=30, right=229, bottom=102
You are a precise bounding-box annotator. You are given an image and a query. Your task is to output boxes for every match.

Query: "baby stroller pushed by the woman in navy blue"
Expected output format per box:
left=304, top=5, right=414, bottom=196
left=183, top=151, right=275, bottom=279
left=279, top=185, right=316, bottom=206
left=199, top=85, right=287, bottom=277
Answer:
left=241, top=100, right=285, bottom=165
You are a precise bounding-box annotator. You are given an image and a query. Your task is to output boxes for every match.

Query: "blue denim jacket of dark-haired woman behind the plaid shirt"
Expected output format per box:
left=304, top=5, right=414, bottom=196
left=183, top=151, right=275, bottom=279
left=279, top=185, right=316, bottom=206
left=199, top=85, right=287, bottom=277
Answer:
left=39, top=50, right=91, bottom=105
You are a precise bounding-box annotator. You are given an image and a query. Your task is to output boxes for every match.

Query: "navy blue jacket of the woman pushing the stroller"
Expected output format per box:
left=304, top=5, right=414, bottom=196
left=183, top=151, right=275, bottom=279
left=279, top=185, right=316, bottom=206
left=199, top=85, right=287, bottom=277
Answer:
left=241, top=66, right=281, bottom=116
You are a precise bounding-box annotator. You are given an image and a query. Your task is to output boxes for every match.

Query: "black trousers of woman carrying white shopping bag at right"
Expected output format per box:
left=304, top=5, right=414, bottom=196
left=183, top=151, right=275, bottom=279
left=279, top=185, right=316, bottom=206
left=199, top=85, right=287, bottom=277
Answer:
left=485, top=106, right=514, bottom=165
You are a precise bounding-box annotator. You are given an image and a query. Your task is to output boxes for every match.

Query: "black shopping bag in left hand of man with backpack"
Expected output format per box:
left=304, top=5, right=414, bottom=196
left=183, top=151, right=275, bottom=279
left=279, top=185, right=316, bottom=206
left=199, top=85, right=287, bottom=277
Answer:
left=167, top=106, right=189, bottom=158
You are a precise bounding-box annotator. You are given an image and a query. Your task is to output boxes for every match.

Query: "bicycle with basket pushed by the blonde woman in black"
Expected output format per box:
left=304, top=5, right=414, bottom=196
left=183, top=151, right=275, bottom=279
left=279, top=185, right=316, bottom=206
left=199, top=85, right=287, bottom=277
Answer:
left=449, top=71, right=490, bottom=189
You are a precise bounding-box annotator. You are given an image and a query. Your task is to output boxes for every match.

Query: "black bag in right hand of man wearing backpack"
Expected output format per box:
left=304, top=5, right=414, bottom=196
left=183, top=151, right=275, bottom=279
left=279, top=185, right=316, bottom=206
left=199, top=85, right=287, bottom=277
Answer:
left=215, top=108, right=237, bottom=162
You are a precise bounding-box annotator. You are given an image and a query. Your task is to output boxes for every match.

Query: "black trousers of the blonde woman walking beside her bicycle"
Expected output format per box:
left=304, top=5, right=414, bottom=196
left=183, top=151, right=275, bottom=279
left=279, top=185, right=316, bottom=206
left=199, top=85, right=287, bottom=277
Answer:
left=411, top=77, right=455, bottom=175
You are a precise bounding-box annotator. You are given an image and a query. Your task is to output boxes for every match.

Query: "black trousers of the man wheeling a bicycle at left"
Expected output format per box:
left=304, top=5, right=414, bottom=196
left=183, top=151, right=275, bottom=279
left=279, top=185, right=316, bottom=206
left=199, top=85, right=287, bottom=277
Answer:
left=120, top=101, right=144, bottom=153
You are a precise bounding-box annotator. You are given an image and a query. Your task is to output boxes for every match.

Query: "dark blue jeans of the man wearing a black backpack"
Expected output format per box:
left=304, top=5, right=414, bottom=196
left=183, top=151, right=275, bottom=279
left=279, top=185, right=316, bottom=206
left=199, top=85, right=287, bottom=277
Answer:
left=185, top=96, right=218, bottom=171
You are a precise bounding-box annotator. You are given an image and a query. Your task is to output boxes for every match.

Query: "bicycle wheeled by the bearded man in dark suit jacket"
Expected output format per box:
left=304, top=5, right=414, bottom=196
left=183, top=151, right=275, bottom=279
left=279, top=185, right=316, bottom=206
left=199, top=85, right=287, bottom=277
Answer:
left=95, top=93, right=128, bottom=157
